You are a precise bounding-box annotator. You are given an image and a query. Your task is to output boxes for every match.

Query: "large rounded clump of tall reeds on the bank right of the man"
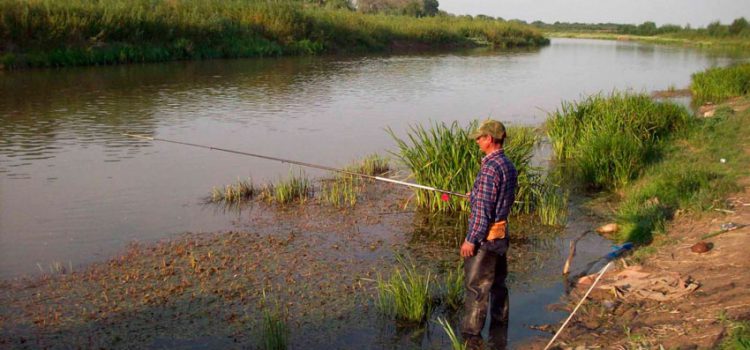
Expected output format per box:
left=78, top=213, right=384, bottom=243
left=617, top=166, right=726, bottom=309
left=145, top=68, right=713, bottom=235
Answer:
left=546, top=92, right=690, bottom=189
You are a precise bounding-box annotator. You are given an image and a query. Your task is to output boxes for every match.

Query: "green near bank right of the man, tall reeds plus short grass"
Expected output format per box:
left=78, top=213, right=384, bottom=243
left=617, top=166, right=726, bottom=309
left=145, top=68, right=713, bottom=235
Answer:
left=546, top=83, right=750, bottom=243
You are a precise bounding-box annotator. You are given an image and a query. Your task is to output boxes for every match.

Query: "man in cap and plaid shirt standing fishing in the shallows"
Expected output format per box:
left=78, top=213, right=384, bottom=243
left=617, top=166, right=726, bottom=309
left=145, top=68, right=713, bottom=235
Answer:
left=461, top=120, right=517, bottom=347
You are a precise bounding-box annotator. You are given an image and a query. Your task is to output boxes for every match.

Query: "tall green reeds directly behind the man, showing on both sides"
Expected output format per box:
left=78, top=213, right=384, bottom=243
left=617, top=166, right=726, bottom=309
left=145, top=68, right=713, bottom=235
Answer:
left=387, top=121, right=567, bottom=226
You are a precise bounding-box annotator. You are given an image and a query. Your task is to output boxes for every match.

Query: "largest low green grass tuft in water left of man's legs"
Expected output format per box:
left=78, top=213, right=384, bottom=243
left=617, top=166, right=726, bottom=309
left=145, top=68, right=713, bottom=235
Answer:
left=375, top=256, right=432, bottom=322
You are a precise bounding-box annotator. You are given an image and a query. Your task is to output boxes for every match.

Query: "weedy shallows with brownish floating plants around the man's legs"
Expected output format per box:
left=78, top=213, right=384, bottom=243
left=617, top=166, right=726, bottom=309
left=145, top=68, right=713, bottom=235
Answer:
left=0, top=180, right=606, bottom=348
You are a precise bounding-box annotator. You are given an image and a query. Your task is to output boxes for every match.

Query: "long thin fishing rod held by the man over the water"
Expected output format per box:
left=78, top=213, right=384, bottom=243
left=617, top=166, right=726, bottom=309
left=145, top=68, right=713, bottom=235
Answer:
left=122, top=134, right=469, bottom=200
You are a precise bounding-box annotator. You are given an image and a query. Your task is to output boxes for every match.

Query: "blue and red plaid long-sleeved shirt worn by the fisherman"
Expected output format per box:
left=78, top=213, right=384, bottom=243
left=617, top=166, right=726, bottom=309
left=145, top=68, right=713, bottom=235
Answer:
left=466, top=149, right=518, bottom=245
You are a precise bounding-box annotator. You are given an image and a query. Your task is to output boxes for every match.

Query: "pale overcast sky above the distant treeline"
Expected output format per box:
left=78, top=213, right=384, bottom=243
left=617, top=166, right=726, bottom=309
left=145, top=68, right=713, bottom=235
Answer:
left=438, top=0, right=750, bottom=28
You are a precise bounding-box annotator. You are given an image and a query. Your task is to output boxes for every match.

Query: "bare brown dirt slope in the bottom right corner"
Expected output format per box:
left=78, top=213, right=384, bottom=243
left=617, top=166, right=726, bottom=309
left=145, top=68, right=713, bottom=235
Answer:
left=534, top=181, right=750, bottom=349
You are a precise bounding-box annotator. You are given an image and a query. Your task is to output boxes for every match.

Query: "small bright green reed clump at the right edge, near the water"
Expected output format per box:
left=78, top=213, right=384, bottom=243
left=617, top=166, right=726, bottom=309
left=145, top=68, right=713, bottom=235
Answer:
left=690, top=63, right=750, bottom=104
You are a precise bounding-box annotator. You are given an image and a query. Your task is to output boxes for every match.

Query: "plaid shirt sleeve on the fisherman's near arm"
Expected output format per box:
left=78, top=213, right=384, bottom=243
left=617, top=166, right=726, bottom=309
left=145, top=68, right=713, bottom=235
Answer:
left=466, top=167, right=499, bottom=245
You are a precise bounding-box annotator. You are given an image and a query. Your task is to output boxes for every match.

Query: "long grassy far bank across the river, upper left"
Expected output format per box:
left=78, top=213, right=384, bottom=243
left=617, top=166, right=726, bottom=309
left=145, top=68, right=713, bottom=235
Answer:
left=0, top=0, right=548, bottom=69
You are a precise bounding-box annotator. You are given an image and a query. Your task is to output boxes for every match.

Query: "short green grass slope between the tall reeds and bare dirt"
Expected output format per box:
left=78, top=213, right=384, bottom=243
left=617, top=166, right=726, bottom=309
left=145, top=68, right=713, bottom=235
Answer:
left=616, top=97, right=750, bottom=243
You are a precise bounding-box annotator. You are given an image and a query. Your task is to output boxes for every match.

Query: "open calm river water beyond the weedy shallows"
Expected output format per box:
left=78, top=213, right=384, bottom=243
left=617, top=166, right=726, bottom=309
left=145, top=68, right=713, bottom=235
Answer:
left=0, top=39, right=737, bottom=344
